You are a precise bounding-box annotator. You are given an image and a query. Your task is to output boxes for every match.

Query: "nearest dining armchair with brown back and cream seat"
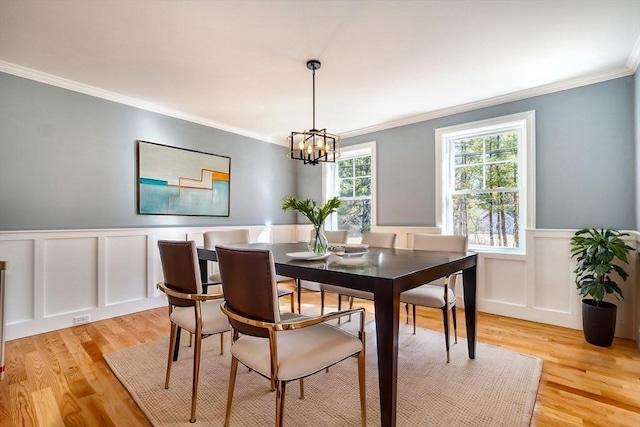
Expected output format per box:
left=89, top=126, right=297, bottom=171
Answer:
left=216, top=246, right=367, bottom=427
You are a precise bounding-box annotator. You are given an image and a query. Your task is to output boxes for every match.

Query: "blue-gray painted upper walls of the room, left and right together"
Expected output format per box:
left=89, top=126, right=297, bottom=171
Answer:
left=0, top=74, right=640, bottom=231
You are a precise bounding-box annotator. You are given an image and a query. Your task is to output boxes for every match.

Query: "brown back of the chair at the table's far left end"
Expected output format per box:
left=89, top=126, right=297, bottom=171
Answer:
left=158, top=240, right=202, bottom=307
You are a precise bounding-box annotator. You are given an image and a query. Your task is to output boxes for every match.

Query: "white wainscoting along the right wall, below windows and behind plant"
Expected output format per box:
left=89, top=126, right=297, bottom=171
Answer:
left=374, top=226, right=640, bottom=346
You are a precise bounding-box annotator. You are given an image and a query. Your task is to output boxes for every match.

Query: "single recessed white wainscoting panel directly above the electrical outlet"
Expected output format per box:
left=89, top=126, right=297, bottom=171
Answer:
left=43, top=236, right=98, bottom=317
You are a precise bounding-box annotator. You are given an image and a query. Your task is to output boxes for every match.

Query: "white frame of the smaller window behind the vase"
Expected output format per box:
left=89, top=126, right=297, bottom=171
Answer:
left=322, top=141, right=378, bottom=230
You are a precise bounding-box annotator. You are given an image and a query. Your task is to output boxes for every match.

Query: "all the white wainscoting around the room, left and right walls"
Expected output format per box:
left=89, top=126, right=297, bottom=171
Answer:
left=0, top=224, right=640, bottom=341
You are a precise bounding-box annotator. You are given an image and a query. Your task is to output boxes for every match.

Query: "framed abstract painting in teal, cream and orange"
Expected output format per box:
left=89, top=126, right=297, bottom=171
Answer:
left=137, top=140, right=231, bottom=216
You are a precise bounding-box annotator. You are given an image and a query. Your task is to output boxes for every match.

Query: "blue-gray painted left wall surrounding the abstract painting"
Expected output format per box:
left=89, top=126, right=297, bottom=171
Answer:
left=0, top=73, right=297, bottom=231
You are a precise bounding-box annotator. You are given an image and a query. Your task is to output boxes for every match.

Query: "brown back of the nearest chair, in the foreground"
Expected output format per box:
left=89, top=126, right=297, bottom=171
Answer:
left=216, top=246, right=280, bottom=337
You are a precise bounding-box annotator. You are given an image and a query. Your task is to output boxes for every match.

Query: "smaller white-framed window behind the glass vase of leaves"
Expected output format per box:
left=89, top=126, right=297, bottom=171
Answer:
left=323, top=142, right=375, bottom=239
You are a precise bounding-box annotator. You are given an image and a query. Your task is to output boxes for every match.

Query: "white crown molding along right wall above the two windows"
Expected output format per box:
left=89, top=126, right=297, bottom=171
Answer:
left=340, top=66, right=640, bottom=139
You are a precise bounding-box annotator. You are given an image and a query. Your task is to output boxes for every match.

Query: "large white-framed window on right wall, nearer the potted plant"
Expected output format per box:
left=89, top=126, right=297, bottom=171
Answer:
left=436, top=111, right=535, bottom=251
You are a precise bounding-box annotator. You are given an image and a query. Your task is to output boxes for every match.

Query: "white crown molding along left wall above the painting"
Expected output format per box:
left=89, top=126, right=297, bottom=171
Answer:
left=0, top=61, right=282, bottom=145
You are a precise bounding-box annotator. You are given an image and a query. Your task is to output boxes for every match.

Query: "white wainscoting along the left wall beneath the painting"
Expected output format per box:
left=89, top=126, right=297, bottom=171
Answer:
left=0, top=225, right=298, bottom=340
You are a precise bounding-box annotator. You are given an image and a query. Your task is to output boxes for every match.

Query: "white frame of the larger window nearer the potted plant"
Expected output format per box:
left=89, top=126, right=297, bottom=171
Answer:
left=435, top=111, right=536, bottom=253
